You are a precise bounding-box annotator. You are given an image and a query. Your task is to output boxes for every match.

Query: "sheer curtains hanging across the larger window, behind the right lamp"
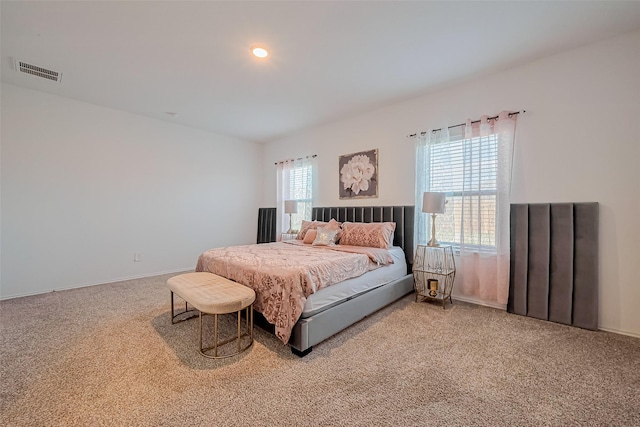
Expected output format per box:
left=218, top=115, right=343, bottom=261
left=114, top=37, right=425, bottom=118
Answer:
left=415, top=112, right=517, bottom=305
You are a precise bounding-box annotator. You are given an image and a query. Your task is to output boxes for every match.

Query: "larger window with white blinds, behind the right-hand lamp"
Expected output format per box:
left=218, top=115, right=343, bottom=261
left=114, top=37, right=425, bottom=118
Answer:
left=425, top=134, right=498, bottom=251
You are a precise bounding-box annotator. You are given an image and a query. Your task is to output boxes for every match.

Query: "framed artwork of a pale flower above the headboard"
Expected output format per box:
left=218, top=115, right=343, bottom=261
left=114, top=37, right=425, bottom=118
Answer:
left=338, top=148, right=378, bottom=199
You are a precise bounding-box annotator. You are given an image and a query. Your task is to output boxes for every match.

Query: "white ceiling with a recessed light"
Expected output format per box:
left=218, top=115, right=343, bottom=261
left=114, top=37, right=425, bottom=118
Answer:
left=0, top=1, right=640, bottom=142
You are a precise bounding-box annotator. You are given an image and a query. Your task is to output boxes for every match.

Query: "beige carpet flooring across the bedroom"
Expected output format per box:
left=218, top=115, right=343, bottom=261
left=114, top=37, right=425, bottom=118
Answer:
left=0, top=275, right=640, bottom=426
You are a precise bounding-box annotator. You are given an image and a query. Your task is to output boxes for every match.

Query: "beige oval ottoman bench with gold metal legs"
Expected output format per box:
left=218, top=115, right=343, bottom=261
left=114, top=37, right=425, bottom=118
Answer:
left=167, top=273, right=256, bottom=359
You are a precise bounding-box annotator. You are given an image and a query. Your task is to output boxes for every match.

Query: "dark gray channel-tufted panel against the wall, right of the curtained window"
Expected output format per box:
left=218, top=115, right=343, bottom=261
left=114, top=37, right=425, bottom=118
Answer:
left=507, top=203, right=599, bottom=329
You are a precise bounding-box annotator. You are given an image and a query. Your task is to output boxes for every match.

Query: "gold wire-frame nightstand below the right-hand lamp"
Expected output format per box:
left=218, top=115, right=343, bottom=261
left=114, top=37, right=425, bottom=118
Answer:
left=413, top=245, right=456, bottom=309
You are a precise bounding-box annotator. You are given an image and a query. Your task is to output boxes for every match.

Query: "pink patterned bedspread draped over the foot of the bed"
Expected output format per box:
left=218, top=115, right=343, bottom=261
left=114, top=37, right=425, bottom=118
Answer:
left=196, top=242, right=391, bottom=344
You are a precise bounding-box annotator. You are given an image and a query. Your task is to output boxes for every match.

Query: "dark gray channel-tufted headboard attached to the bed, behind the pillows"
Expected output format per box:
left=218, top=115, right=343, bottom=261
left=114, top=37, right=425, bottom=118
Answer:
left=311, top=206, right=414, bottom=273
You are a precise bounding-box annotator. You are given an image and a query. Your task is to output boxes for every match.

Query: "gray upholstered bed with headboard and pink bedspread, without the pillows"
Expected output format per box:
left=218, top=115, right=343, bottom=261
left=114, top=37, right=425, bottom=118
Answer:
left=196, top=206, right=414, bottom=356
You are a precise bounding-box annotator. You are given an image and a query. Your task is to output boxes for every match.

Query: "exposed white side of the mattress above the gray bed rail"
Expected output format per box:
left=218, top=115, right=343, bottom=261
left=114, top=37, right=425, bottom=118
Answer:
left=300, top=246, right=407, bottom=318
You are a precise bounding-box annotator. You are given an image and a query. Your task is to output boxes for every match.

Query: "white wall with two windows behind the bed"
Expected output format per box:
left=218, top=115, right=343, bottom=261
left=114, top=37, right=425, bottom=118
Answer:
left=263, top=31, right=640, bottom=336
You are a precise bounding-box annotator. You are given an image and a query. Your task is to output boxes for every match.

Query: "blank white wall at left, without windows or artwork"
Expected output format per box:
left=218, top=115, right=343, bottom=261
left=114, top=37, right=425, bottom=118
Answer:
left=0, top=84, right=262, bottom=298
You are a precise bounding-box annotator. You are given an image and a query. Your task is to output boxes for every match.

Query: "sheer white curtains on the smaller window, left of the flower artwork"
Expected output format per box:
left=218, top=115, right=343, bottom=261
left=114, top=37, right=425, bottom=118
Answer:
left=276, top=156, right=317, bottom=240
